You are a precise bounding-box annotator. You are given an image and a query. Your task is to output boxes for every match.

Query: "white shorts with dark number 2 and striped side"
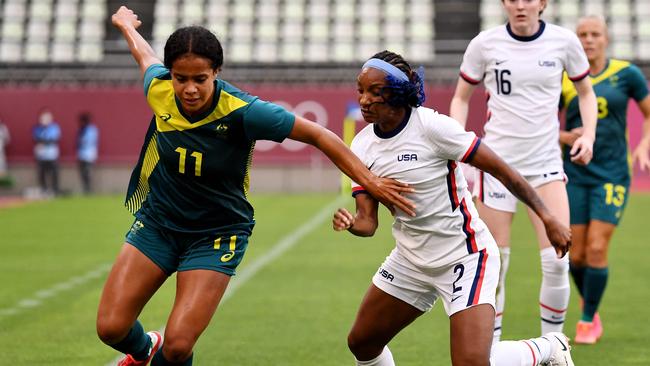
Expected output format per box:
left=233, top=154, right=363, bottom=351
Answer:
left=372, top=245, right=501, bottom=316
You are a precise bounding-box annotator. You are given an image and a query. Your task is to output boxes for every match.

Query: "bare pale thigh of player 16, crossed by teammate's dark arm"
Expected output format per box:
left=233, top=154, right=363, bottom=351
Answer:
left=528, top=180, right=570, bottom=249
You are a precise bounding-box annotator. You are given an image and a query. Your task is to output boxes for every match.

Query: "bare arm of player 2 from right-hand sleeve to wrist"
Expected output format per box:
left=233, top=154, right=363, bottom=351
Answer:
left=469, top=143, right=550, bottom=222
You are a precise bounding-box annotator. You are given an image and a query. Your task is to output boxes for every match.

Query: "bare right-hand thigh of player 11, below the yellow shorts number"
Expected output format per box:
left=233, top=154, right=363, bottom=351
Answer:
left=165, top=269, right=230, bottom=352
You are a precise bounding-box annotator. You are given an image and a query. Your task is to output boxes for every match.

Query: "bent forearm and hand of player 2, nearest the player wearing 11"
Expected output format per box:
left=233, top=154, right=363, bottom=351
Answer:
left=332, top=193, right=379, bottom=236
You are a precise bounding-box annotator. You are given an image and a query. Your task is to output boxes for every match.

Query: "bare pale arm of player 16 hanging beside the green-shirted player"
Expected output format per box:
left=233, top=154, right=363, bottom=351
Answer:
left=570, top=77, right=598, bottom=165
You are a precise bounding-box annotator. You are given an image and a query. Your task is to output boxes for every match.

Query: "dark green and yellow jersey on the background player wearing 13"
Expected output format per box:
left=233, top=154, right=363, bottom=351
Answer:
left=561, top=59, right=648, bottom=185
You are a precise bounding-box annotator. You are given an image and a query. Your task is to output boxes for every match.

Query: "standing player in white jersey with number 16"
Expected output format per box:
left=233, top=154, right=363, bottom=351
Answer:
left=450, top=0, right=597, bottom=341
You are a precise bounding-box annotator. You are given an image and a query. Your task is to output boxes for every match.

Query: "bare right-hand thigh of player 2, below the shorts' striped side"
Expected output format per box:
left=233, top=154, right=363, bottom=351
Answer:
left=449, top=304, right=495, bottom=366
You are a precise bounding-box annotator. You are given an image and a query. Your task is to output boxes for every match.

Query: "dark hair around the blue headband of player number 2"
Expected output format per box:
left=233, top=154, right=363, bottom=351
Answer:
left=371, top=50, right=426, bottom=107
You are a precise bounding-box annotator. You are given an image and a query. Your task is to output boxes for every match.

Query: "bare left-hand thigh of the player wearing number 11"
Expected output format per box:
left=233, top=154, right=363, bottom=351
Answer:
left=97, top=243, right=168, bottom=341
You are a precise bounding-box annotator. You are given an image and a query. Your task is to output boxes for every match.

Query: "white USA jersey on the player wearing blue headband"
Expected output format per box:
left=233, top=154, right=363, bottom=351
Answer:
left=351, top=107, right=496, bottom=268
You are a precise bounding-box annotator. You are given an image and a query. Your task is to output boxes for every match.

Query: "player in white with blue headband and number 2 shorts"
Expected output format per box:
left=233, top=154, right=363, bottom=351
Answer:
left=332, top=51, right=573, bottom=366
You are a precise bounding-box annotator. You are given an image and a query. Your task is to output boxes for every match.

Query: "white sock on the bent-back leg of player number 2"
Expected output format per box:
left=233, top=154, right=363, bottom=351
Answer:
left=490, top=338, right=552, bottom=366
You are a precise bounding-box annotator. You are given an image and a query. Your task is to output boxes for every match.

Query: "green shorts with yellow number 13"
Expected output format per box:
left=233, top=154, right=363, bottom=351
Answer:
left=567, top=180, right=630, bottom=225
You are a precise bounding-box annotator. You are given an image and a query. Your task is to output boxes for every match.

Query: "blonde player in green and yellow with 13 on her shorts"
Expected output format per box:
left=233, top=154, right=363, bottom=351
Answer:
left=560, top=16, right=650, bottom=344
